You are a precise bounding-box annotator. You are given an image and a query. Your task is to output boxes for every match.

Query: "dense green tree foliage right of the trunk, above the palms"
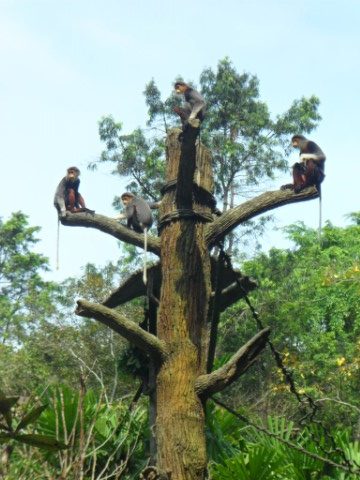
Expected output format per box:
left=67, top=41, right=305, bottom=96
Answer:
left=219, top=216, right=360, bottom=429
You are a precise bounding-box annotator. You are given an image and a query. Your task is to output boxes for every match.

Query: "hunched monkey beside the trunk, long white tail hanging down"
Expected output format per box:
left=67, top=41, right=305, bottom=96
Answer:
left=116, top=192, right=154, bottom=285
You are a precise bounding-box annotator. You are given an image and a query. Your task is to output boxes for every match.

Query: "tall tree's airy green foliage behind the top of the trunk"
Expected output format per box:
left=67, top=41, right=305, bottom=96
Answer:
left=93, top=58, right=320, bottom=209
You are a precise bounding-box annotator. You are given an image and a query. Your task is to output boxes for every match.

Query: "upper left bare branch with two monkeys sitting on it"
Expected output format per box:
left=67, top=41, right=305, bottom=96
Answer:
left=61, top=212, right=160, bottom=255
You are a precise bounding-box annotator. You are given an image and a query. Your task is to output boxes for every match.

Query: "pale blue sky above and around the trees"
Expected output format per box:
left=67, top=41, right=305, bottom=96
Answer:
left=0, top=0, right=360, bottom=281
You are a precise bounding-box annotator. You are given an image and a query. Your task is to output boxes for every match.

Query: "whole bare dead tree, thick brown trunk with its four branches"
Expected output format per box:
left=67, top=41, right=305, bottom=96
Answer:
left=74, top=128, right=317, bottom=480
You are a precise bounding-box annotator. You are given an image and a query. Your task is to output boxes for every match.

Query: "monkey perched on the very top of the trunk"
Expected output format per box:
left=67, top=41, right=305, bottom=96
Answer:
left=174, top=82, right=206, bottom=132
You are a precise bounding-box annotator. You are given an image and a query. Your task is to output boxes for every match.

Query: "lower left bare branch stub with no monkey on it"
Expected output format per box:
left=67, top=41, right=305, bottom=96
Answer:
left=75, top=300, right=167, bottom=361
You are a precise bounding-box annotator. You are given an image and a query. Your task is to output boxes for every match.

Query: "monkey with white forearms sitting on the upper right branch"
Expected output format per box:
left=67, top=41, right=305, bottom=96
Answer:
left=280, top=135, right=326, bottom=195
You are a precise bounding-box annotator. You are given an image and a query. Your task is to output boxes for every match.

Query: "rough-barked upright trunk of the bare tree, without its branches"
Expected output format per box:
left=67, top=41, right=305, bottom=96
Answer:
left=156, top=125, right=210, bottom=480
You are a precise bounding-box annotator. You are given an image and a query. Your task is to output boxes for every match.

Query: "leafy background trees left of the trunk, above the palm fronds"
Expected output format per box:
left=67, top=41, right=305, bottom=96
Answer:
left=0, top=216, right=143, bottom=400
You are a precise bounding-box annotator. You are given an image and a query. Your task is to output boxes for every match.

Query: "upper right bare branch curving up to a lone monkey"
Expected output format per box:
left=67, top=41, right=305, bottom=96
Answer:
left=206, top=187, right=319, bottom=245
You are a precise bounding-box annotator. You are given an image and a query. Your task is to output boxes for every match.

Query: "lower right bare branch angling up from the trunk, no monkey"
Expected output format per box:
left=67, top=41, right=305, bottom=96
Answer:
left=195, top=328, right=270, bottom=399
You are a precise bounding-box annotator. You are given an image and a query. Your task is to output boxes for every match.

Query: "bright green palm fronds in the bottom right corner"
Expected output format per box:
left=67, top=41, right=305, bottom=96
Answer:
left=211, top=408, right=360, bottom=480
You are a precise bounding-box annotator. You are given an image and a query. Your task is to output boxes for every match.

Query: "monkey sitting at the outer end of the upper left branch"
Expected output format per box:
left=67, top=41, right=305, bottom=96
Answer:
left=54, top=167, right=95, bottom=218
